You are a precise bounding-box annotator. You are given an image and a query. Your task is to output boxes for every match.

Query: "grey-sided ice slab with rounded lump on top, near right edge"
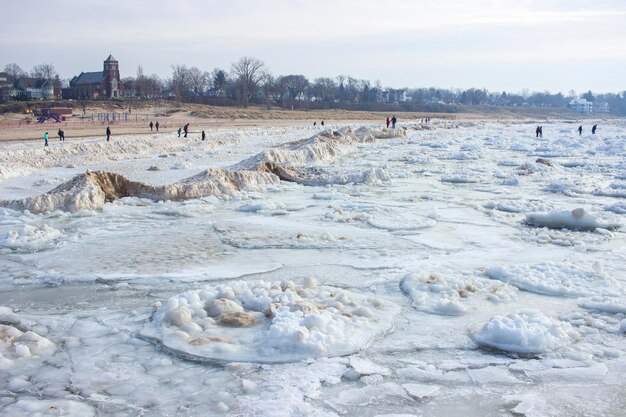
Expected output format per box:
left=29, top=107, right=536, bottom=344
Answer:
left=526, top=208, right=621, bottom=231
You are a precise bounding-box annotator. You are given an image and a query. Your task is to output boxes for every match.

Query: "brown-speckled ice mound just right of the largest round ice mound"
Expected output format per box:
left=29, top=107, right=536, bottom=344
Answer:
left=400, top=273, right=517, bottom=316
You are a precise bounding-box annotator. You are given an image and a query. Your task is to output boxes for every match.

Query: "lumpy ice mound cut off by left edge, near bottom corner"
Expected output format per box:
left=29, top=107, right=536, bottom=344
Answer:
left=0, top=324, right=56, bottom=368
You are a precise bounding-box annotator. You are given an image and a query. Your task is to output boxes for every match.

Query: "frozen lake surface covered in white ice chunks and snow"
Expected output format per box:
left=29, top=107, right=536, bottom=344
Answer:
left=0, top=120, right=626, bottom=417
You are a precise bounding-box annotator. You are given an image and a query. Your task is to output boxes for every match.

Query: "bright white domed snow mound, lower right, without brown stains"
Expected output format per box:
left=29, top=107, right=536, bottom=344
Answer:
left=471, top=309, right=576, bottom=354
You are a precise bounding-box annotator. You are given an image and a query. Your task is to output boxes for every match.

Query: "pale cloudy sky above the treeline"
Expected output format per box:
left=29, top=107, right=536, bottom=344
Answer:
left=0, top=0, right=626, bottom=93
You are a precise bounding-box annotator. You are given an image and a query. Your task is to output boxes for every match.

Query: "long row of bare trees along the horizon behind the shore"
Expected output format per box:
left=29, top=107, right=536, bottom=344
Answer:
left=4, top=57, right=626, bottom=115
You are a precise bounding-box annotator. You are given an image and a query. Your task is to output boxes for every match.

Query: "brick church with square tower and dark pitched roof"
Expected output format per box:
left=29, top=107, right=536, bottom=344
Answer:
left=63, top=55, right=124, bottom=99
